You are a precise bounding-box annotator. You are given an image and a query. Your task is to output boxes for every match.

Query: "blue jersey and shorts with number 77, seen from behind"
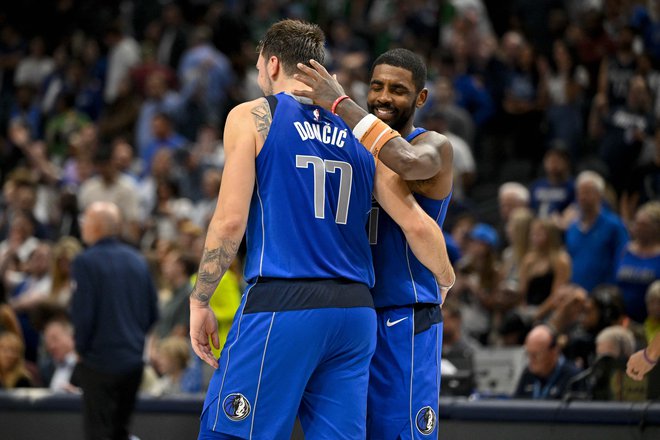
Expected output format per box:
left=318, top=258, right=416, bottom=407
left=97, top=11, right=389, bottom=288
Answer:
left=199, top=94, right=376, bottom=439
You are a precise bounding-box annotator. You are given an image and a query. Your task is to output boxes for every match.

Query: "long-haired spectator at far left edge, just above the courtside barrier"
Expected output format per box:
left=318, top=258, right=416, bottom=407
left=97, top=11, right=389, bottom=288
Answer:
left=0, top=332, right=32, bottom=390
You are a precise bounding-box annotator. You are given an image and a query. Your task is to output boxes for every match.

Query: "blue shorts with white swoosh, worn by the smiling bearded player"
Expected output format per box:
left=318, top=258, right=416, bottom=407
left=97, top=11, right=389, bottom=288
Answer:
left=367, top=304, right=442, bottom=440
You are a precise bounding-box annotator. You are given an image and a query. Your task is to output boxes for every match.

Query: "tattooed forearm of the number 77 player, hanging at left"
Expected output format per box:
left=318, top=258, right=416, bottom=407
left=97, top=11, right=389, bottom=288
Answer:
left=190, top=239, right=241, bottom=304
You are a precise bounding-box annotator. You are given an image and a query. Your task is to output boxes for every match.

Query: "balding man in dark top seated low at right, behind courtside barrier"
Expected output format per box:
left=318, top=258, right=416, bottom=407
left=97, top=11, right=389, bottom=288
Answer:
left=513, top=325, right=580, bottom=399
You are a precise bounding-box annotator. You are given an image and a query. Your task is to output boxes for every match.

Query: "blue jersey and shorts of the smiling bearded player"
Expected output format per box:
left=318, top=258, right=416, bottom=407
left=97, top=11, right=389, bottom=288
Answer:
left=367, top=128, right=451, bottom=440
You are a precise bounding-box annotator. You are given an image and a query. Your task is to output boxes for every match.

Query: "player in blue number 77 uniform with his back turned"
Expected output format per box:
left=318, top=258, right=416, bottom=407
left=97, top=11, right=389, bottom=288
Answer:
left=190, top=20, right=453, bottom=440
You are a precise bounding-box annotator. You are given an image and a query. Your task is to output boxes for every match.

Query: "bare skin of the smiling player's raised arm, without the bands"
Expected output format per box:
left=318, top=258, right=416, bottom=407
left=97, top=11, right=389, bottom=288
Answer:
left=294, top=60, right=442, bottom=180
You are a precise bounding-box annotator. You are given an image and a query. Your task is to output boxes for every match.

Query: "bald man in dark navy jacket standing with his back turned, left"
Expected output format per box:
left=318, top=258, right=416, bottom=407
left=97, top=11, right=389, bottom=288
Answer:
left=71, top=202, right=157, bottom=440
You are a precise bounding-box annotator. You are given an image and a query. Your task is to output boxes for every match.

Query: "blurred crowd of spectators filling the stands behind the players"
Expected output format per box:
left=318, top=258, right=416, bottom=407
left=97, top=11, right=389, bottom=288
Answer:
left=0, top=0, right=660, bottom=399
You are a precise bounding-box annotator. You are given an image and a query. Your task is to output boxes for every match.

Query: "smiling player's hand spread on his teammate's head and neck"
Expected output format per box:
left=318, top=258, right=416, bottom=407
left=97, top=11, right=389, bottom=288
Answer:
left=293, top=60, right=345, bottom=110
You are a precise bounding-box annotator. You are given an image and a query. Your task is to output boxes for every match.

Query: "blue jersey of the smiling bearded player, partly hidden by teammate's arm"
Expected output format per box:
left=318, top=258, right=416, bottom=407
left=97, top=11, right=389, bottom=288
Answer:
left=369, top=128, right=451, bottom=307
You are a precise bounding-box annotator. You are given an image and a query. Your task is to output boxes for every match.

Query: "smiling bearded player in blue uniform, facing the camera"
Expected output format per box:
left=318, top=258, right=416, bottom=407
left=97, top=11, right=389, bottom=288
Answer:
left=296, top=49, right=453, bottom=440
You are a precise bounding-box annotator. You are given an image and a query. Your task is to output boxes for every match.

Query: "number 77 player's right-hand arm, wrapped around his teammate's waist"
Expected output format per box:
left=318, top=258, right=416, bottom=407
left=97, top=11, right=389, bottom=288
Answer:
left=374, top=165, right=455, bottom=290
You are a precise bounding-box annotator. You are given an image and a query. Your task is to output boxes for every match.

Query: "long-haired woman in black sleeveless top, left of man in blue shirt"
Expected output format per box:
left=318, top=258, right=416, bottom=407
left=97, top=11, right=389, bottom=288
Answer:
left=519, top=219, right=572, bottom=321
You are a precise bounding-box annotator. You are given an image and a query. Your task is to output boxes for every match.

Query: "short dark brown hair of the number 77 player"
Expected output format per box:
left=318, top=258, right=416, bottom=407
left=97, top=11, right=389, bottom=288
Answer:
left=257, top=19, right=325, bottom=75
